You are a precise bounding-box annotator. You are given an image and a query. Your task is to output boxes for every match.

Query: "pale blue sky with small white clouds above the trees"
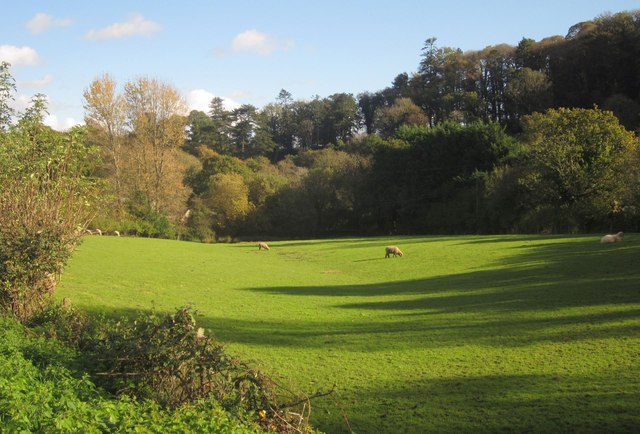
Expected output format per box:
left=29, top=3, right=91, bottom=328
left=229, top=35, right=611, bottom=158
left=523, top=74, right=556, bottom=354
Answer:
left=0, top=0, right=640, bottom=130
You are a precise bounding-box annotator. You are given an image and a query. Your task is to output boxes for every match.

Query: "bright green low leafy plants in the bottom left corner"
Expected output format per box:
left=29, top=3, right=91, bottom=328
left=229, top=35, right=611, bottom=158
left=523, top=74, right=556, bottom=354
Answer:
left=0, top=317, right=262, bottom=433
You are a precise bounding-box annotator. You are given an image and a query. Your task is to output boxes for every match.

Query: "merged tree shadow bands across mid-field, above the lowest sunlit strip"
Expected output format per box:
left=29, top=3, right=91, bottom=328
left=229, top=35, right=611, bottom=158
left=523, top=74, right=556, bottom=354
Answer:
left=203, top=238, right=640, bottom=351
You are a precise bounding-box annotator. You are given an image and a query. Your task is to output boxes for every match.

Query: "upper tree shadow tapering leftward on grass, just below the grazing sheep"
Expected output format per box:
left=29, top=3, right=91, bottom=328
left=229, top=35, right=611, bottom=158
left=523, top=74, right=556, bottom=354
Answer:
left=242, top=240, right=640, bottom=312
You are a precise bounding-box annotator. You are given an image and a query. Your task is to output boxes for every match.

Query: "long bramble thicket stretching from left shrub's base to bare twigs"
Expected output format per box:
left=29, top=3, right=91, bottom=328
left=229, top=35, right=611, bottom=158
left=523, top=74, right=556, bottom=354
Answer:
left=23, top=303, right=324, bottom=433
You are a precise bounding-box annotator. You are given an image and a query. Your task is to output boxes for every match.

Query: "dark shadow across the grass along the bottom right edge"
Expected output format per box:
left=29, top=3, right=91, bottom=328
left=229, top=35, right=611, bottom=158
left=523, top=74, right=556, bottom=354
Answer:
left=336, top=370, right=640, bottom=433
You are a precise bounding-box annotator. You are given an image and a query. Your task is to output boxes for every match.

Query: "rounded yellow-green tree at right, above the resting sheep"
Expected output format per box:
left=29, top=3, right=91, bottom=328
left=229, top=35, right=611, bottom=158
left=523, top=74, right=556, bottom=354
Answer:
left=522, top=109, right=638, bottom=230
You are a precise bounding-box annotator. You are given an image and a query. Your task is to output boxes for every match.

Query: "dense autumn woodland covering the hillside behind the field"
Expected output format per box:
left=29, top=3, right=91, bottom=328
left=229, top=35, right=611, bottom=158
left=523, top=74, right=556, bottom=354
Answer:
left=79, top=10, right=640, bottom=242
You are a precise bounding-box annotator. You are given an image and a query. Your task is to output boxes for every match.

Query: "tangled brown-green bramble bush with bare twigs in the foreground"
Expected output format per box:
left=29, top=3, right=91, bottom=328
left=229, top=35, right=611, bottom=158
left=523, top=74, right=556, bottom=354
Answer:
left=82, top=308, right=320, bottom=432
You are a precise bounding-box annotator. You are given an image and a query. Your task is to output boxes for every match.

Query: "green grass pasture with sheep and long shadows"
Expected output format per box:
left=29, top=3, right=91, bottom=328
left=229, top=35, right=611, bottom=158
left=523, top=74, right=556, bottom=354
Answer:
left=57, top=234, right=640, bottom=433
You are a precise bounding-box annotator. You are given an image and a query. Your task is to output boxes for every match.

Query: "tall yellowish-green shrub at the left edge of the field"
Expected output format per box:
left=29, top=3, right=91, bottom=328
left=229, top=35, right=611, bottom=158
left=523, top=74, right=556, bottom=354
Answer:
left=0, top=104, right=97, bottom=320
